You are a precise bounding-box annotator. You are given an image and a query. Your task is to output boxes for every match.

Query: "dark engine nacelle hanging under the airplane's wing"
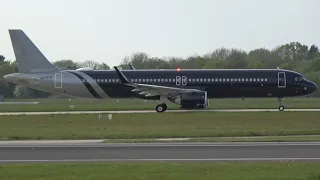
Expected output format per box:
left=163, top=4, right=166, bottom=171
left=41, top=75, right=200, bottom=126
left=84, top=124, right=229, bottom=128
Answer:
left=173, top=92, right=209, bottom=109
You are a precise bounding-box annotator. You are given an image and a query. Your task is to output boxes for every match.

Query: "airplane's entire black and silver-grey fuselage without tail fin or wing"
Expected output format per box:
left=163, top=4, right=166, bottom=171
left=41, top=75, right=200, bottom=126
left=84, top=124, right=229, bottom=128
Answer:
left=7, top=69, right=317, bottom=99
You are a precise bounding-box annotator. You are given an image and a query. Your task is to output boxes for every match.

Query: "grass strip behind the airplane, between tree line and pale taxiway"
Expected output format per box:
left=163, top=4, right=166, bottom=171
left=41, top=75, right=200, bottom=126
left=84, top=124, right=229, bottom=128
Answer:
left=0, top=98, right=320, bottom=112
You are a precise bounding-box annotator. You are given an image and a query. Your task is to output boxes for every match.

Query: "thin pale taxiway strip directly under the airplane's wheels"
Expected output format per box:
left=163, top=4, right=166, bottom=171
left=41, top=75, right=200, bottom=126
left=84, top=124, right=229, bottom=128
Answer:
left=0, top=109, right=320, bottom=116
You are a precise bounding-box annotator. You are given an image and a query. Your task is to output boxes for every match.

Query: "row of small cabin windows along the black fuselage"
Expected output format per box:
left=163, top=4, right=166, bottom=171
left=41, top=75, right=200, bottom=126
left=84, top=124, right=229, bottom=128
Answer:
left=82, top=78, right=268, bottom=83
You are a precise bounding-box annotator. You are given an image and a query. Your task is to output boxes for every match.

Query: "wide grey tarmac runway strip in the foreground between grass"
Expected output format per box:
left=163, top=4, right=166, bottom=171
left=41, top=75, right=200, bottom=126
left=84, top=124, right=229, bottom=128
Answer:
left=0, top=141, right=320, bottom=164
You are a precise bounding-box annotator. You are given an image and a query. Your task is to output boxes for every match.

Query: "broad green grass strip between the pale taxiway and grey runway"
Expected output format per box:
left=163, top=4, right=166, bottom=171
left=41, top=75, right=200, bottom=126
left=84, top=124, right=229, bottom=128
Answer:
left=0, top=112, right=320, bottom=139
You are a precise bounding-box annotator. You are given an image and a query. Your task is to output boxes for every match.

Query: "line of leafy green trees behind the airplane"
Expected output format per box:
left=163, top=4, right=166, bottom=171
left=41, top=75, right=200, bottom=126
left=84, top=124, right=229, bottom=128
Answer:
left=0, top=42, right=320, bottom=98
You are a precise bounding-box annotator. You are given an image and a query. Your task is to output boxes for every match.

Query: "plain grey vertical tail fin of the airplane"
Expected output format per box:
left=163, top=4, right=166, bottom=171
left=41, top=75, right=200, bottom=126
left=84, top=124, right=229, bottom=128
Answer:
left=9, top=29, right=59, bottom=73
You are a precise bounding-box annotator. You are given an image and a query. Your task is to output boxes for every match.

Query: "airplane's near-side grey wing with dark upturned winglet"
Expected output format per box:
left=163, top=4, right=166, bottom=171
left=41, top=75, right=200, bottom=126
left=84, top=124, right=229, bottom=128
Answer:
left=114, top=67, right=204, bottom=97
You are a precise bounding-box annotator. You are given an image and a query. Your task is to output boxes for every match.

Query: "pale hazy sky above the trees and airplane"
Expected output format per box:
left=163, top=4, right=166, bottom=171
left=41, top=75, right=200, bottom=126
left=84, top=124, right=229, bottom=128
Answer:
left=0, top=0, right=320, bottom=66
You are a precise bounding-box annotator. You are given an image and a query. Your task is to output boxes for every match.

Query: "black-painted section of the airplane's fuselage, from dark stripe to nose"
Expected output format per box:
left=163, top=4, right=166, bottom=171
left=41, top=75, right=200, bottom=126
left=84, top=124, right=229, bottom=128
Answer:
left=77, top=69, right=317, bottom=99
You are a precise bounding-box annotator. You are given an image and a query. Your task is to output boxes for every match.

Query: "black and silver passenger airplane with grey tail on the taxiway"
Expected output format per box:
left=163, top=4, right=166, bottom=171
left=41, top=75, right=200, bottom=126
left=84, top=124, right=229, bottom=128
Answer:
left=4, top=29, right=318, bottom=113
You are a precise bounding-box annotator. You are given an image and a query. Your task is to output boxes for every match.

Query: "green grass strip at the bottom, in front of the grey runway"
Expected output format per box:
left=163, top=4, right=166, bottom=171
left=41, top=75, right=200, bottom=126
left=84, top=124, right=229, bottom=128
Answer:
left=0, top=162, right=320, bottom=180
